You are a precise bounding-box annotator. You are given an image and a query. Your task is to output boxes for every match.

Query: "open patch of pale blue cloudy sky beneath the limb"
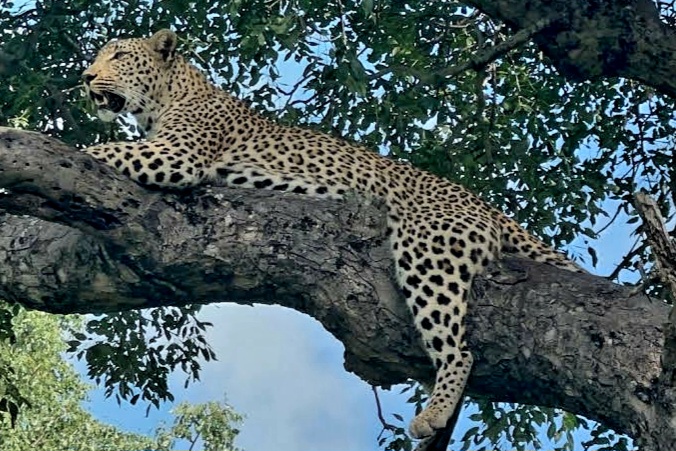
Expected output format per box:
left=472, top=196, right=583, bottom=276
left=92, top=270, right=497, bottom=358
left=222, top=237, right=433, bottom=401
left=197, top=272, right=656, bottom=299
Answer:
left=83, top=305, right=411, bottom=451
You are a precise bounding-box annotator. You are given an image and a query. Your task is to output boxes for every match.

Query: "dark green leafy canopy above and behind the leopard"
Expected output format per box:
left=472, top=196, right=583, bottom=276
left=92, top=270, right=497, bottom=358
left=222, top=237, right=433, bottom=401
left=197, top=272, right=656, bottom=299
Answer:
left=1, top=0, right=673, bottom=268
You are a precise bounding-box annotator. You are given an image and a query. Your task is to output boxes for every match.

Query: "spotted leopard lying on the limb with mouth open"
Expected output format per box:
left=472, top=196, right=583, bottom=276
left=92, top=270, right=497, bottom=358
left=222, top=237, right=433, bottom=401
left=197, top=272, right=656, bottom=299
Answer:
left=82, top=29, right=583, bottom=439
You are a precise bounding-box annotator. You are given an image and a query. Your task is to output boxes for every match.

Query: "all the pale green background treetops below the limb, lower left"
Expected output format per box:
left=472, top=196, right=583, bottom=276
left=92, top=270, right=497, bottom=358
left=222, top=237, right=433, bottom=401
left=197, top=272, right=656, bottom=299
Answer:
left=0, top=303, right=242, bottom=451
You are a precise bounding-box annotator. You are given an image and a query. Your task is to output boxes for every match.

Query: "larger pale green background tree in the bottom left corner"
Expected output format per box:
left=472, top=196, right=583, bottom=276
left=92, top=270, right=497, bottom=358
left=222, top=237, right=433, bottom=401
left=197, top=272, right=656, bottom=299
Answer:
left=0, top=303, right=152, bottom=451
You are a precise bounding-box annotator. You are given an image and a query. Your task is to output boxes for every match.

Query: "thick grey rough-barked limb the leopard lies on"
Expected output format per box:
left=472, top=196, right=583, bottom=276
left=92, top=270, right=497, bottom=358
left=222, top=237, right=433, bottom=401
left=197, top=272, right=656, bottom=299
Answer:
left=0, top=129, right=676, bottom=451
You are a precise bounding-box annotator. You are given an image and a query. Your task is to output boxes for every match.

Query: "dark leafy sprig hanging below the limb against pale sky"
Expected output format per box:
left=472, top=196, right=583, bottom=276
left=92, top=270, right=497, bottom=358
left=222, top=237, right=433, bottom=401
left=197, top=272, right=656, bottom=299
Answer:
left=68, top=306, right=216, bottom=414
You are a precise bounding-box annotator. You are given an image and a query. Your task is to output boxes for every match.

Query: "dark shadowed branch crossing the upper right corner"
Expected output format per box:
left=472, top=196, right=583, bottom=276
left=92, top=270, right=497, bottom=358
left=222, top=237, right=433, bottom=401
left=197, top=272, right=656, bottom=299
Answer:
left=467, top=0, right=676, bottom=97
